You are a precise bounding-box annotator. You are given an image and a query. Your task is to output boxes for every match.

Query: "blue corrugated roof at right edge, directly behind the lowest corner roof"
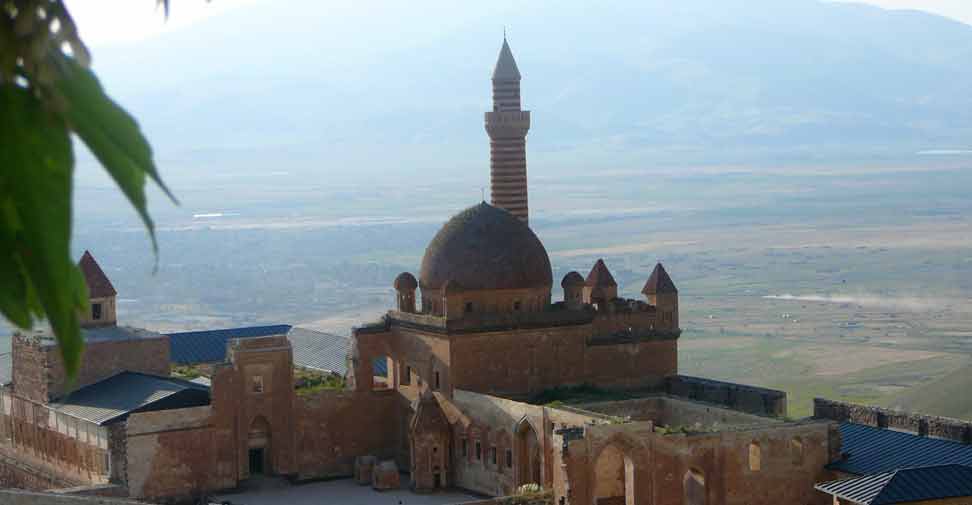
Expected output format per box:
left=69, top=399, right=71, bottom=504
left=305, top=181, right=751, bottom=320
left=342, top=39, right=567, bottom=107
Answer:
left=828, top=423, right=972, bottom=475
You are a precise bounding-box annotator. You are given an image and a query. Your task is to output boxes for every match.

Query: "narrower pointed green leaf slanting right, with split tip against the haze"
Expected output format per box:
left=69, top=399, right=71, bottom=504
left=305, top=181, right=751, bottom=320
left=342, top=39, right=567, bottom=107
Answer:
left=51, top=54, right=178, bottom=258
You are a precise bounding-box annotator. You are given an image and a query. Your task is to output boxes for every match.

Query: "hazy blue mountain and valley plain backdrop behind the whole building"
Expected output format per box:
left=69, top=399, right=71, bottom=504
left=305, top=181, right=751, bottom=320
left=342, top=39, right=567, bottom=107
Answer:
left=3, top=0, right=972, bottom=418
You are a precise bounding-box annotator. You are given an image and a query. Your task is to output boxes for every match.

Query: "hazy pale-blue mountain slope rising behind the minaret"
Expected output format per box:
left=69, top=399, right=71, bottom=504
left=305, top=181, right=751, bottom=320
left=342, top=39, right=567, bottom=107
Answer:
left=79, top=0, right=972, bottom=187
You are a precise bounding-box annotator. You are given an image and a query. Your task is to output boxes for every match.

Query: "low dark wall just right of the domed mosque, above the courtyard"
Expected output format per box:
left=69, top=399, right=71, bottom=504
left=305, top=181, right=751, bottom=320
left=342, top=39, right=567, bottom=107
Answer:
left=665, top=375, right=787, bottom=416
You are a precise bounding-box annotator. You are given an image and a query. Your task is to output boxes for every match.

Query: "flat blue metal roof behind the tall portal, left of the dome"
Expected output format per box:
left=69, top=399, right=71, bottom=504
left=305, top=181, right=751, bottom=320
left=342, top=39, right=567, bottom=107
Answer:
left=168, top=324, right=290, bottom=365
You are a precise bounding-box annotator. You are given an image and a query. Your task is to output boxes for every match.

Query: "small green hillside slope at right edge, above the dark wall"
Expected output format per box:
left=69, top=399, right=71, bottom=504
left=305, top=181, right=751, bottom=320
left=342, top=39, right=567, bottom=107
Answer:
left=885, top=365, right=972, bottom=420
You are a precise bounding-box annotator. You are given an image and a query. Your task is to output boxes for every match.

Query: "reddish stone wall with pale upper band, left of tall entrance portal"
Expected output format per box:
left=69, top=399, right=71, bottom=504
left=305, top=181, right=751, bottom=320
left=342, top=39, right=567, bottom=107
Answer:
left=125, top=406, right=237, bottom=499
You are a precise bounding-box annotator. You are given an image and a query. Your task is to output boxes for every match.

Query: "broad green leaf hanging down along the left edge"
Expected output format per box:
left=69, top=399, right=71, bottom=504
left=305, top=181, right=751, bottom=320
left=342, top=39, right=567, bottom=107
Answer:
left=0, top=84, right=87, bottom=377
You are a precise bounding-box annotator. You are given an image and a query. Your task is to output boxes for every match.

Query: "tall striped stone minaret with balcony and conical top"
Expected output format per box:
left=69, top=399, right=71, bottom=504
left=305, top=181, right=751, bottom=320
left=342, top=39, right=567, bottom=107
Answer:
left=486, top=35, right=530, bottom=224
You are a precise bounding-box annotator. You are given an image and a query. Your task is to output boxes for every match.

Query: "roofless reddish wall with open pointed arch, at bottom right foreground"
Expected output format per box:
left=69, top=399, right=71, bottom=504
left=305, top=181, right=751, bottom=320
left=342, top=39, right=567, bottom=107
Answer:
left=554, top=422, right=836, bottom=505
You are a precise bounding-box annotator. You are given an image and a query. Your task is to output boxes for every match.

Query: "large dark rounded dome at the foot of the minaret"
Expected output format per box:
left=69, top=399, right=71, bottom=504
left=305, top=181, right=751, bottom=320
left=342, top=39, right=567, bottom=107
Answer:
left=419, top=202, right=553, bottom=290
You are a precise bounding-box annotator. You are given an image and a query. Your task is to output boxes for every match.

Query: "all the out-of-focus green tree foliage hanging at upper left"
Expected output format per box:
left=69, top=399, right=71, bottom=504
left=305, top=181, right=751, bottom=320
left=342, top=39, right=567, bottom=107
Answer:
left=0, top=0, right=177, bottom=377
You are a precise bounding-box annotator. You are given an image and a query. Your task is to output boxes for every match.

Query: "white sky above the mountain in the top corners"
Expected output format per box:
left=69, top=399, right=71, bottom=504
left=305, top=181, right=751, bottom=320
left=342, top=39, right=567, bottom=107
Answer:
left=68, top=0, right=972, bottom=47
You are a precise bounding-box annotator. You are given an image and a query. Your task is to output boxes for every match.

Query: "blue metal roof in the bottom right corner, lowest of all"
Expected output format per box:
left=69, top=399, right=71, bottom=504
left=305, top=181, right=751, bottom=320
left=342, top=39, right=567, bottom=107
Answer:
left=814, top=465, right=972, bottom=505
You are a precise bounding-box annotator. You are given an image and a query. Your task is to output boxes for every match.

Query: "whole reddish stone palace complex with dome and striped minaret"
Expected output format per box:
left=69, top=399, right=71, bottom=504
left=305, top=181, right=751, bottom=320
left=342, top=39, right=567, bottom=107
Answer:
left=0, top=36, right=972, bottom=505
